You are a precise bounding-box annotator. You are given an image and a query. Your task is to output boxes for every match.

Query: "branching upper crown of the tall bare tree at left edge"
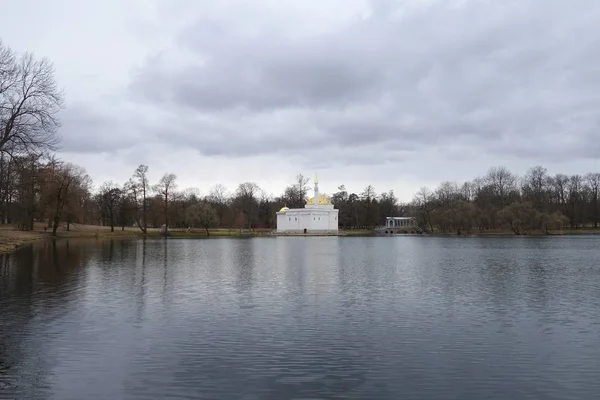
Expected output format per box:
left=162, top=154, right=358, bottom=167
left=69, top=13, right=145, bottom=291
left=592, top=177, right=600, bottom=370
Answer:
left=0, top=42, right=64, bottom=156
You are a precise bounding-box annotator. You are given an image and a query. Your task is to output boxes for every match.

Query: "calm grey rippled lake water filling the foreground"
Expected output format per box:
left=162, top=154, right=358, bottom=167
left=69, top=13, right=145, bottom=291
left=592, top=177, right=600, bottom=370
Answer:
left=0, top=237, right=600, bottom=400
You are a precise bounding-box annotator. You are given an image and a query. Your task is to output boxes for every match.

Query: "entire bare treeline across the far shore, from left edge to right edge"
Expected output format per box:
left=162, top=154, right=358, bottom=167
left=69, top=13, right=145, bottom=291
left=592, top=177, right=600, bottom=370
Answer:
left=0, top=155, right=600, bottom=234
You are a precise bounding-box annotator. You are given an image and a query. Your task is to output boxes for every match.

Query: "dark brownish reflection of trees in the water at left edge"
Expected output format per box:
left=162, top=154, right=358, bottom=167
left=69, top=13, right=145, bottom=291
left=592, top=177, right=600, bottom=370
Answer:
left=0, top=240, right=94, bottom=398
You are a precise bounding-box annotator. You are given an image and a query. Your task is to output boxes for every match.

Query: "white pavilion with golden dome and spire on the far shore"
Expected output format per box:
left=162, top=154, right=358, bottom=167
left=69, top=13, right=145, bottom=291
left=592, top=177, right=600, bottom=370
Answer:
left=277, top=177, right=339, bottom=234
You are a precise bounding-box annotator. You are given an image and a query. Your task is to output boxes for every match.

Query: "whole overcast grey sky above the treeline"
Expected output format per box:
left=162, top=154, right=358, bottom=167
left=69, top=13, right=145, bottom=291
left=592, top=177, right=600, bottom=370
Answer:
left=0, top=0, right=600, bottom=201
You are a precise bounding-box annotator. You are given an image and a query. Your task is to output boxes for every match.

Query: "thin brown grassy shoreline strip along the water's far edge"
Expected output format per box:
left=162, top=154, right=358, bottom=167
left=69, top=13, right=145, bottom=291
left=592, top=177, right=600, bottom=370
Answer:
left=0, top=224, right=600, bottom=254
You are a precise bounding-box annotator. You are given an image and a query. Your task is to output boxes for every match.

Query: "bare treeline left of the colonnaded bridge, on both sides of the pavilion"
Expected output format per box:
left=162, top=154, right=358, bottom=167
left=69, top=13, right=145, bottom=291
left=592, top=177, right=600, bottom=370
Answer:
left=0, top=155, right=404, bottom=233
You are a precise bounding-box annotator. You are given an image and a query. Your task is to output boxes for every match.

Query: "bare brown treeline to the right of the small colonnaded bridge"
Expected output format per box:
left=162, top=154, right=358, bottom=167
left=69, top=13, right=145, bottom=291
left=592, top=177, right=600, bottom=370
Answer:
left=412, top=166, right=600, bottom=235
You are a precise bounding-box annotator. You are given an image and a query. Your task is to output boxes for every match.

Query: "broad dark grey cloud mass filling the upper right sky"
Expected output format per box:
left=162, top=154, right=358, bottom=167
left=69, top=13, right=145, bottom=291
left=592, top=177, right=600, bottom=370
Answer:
left=130, top=0, right=600, bottom=163
